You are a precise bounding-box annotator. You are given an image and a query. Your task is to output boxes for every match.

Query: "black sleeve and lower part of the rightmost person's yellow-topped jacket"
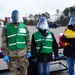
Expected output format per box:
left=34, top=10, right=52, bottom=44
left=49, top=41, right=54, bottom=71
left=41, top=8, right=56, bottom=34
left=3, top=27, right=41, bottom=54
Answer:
left=61, top=27, right=75, bottom=58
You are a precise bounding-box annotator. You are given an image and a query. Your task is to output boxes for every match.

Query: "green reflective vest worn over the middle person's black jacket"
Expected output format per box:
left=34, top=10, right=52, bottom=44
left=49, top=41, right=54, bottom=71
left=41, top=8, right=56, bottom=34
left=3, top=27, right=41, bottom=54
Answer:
left=34, top=31, right=53, bottom=53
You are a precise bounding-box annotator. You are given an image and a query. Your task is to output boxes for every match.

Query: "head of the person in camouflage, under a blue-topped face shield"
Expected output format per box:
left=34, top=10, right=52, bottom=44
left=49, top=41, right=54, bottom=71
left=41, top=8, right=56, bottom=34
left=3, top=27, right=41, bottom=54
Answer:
left=11, top=10, right=23, bottom=23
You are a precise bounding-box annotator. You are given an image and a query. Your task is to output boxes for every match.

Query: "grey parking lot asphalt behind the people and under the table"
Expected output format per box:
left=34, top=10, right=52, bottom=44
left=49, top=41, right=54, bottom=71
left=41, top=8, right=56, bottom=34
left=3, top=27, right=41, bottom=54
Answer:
left=0, top=26, right=68, bottom=75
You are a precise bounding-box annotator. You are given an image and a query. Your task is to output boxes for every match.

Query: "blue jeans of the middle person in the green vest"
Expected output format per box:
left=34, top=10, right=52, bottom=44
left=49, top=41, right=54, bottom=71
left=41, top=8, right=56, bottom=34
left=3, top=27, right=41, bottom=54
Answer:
left=38, top=62, right=50, bottom=75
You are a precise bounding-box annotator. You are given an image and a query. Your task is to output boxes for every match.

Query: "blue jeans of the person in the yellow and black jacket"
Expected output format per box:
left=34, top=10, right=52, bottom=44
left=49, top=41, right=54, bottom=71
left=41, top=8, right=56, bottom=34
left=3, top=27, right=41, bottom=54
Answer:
left=67, top=57, right=75, bottom=75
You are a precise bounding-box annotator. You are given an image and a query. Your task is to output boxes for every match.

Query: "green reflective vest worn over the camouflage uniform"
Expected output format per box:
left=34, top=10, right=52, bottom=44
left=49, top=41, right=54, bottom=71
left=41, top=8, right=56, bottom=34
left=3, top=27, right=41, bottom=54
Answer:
left=6, top=23, right=28, bottom=50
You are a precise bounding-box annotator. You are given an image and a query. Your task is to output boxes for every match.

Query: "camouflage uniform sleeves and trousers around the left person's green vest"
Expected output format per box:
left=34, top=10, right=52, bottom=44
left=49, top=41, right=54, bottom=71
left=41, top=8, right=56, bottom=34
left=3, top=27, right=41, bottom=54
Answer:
left=1, top=25, right=31, bottom=75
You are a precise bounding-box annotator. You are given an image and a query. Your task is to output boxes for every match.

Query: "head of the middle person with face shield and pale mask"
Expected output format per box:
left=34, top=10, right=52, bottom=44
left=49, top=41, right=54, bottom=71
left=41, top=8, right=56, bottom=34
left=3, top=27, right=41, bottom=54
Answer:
left=36, top=17, right=48, bottom=30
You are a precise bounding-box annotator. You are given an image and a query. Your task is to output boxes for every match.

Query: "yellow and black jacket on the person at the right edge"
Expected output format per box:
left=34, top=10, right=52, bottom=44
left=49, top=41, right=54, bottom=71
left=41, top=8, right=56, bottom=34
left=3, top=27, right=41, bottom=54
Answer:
left=61, top=28, right=75, bottom=58
